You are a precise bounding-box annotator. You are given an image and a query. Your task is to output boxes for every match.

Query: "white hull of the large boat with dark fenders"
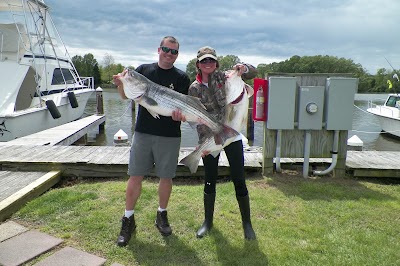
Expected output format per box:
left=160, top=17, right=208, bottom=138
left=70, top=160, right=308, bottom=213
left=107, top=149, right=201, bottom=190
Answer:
left=0, top=89, right=94, bottom=142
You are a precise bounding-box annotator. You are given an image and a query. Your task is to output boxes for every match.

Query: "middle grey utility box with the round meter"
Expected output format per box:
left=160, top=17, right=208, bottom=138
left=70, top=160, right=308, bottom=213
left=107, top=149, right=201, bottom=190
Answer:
left=298, top=86, right=325, bottom=130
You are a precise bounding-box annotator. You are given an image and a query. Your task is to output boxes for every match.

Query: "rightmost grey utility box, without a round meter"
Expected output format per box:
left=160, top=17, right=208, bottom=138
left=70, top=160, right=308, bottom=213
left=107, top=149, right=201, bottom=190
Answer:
left=324, top=77, right=358, bottom=130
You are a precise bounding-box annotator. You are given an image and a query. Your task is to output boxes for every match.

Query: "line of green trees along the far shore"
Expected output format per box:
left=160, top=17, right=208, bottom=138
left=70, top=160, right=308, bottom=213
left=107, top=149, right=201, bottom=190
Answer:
left=72, top=53, right=400, bottom=93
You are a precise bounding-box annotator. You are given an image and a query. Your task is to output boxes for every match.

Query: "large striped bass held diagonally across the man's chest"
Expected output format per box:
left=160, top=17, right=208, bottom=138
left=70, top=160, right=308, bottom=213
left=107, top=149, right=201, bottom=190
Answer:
left=118, top=69, right=239, bottom=144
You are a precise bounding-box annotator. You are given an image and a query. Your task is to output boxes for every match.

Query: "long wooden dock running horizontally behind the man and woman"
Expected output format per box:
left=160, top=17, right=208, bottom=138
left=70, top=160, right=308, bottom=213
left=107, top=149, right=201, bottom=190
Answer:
left=0, top=144, right=400, bottom=177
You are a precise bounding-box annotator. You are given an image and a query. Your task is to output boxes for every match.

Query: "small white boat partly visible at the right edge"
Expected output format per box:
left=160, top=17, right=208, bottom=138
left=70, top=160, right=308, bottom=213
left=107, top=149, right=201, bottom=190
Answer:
left=367, top=94, right=400, bottom=137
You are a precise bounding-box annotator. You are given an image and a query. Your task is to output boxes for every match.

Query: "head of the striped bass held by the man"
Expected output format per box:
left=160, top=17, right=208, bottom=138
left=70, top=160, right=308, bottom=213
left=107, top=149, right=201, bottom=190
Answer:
left=119, top=69, right=149, bottom=100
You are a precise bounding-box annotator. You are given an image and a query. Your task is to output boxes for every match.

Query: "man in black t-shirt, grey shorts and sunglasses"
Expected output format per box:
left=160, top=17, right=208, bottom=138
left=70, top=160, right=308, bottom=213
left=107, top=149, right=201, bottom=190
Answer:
left=113, top=36, right=190, bottom=246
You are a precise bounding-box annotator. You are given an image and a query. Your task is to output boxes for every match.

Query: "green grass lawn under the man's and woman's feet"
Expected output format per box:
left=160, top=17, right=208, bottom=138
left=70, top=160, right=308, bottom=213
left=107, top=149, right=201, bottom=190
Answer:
left=12, top=173, right=400, bottom=266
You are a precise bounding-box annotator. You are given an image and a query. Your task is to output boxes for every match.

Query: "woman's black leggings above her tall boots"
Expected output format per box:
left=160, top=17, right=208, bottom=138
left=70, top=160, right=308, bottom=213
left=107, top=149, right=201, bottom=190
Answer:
left=203, top=140, right=248, bottom=197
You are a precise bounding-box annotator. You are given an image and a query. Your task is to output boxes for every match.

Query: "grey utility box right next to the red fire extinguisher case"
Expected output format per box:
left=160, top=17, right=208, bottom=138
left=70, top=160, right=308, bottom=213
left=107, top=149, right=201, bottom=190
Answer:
left=266, top=77, right=296, bottom=129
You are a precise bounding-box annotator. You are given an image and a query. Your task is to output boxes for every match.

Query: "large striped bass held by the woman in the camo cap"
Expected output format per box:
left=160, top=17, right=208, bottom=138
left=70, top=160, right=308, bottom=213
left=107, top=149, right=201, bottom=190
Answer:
left=180, top=70, right=254, bottom=174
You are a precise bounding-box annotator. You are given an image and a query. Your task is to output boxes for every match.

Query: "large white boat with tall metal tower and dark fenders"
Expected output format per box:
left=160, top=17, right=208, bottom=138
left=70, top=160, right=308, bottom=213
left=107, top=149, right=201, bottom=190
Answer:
left=0, top=0, right=95, bottom=141
